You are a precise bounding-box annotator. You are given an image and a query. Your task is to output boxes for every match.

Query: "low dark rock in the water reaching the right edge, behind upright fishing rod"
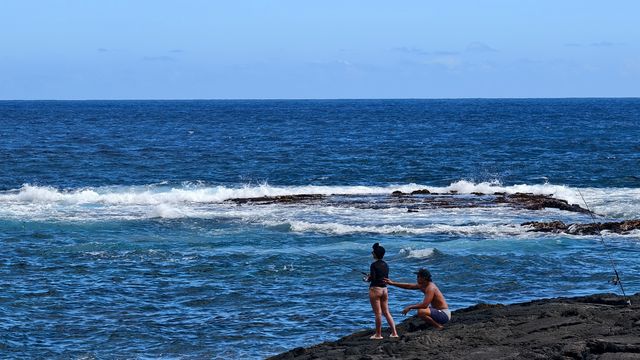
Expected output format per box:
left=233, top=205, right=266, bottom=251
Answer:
left=521, top=220, right=640, bottom=235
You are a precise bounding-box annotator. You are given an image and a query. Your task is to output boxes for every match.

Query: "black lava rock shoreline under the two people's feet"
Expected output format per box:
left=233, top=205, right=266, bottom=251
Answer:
left=270, top=293, right=640, bottom=360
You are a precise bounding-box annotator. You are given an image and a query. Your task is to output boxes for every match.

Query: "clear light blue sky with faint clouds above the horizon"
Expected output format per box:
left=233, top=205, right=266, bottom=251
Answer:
left=0, top=0, right=640, bottom=100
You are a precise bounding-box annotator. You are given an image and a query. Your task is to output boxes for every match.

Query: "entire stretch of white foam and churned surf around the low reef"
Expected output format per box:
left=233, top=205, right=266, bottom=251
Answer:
left=0, top=180, right=640, bottom=228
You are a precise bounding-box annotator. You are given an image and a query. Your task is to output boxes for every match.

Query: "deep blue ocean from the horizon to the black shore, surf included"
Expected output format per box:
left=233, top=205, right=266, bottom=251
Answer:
left=0, top=99, right=640, bottom=359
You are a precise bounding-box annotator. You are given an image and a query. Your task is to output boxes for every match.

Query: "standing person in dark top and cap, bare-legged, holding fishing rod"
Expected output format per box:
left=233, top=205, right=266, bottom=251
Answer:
left=367, top=243, right=398, bottom=340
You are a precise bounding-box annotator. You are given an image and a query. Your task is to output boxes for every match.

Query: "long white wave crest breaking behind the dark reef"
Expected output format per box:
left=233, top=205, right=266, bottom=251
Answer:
left=0, top=180, right=620, bottom=205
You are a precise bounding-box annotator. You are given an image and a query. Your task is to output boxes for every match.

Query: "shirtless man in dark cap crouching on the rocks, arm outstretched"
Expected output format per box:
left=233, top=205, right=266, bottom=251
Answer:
left=384, top=268, right=451, bottom=330
